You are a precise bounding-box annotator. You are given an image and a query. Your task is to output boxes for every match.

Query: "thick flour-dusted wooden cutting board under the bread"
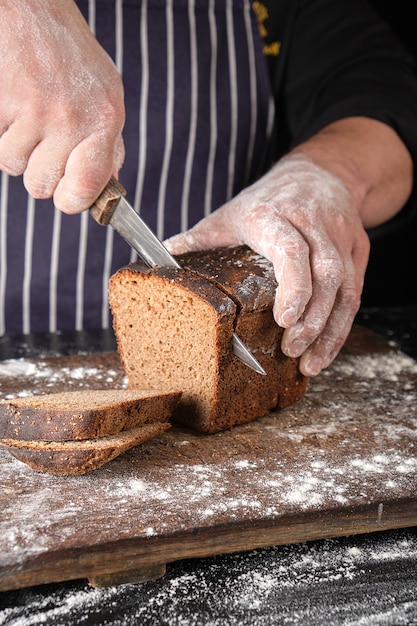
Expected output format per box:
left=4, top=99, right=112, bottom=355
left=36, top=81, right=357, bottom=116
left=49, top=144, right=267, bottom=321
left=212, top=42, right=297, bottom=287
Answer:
left=0, top=327, right=417, bottom=590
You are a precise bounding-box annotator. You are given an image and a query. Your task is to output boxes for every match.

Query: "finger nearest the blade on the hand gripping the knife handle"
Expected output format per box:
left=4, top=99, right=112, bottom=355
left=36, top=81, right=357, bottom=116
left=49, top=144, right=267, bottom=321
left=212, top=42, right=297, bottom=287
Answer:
left=50, top=133, right=122, bottom=213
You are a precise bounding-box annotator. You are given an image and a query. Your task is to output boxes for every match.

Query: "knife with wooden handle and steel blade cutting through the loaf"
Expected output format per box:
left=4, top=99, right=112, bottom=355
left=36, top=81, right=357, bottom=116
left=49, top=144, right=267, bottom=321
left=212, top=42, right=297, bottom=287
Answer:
left=90, top=177, right=266, bottom=375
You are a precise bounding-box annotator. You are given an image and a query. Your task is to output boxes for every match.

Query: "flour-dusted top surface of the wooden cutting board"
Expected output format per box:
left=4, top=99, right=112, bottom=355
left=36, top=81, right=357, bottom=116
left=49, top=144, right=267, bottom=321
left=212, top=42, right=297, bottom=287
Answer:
left=0, top=342, right=417, bottom=580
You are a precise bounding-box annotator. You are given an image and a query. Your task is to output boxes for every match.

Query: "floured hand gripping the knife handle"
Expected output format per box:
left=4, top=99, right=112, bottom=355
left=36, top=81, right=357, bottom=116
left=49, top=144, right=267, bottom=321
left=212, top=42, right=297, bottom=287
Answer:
left=0, top=0, right=124, bottom=213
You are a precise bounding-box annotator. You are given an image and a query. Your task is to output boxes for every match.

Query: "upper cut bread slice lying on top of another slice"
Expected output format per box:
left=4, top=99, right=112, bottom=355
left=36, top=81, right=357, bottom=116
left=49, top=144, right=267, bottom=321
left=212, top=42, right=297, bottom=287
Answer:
left=0, top=387, right=181, bottom=442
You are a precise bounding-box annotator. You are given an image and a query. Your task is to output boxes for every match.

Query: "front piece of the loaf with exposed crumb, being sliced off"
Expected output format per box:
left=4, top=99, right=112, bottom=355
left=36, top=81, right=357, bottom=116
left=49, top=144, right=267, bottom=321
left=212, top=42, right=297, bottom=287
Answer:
left=110, top=267, right=236, bottom=430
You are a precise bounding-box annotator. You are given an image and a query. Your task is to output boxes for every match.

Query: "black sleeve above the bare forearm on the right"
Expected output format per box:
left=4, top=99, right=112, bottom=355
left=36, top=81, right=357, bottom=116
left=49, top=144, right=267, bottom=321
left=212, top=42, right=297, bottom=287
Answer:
left=269, top=0, right=417, bottom=223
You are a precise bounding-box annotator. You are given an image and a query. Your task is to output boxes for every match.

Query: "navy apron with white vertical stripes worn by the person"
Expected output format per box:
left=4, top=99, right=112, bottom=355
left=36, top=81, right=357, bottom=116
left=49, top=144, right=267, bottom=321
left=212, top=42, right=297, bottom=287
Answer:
left=0, top=0, right=274, bottom=335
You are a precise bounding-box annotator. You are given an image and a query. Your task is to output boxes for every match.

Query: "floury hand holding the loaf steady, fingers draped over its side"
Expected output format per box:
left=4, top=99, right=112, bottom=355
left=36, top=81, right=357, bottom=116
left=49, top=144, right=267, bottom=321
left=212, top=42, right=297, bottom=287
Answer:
left=166, top=154, right=369, bottom=376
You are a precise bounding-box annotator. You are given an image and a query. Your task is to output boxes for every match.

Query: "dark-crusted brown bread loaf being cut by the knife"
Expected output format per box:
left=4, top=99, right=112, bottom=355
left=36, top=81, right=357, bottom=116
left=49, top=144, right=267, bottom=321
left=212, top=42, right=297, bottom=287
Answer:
left=109, top=246, right=307, bottom=433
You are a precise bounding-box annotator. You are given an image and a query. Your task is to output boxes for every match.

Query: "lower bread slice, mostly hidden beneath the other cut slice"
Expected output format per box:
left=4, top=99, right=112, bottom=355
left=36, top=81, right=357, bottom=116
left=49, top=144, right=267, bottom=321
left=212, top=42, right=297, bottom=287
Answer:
left=1, top=423, right=170, bottom=476
